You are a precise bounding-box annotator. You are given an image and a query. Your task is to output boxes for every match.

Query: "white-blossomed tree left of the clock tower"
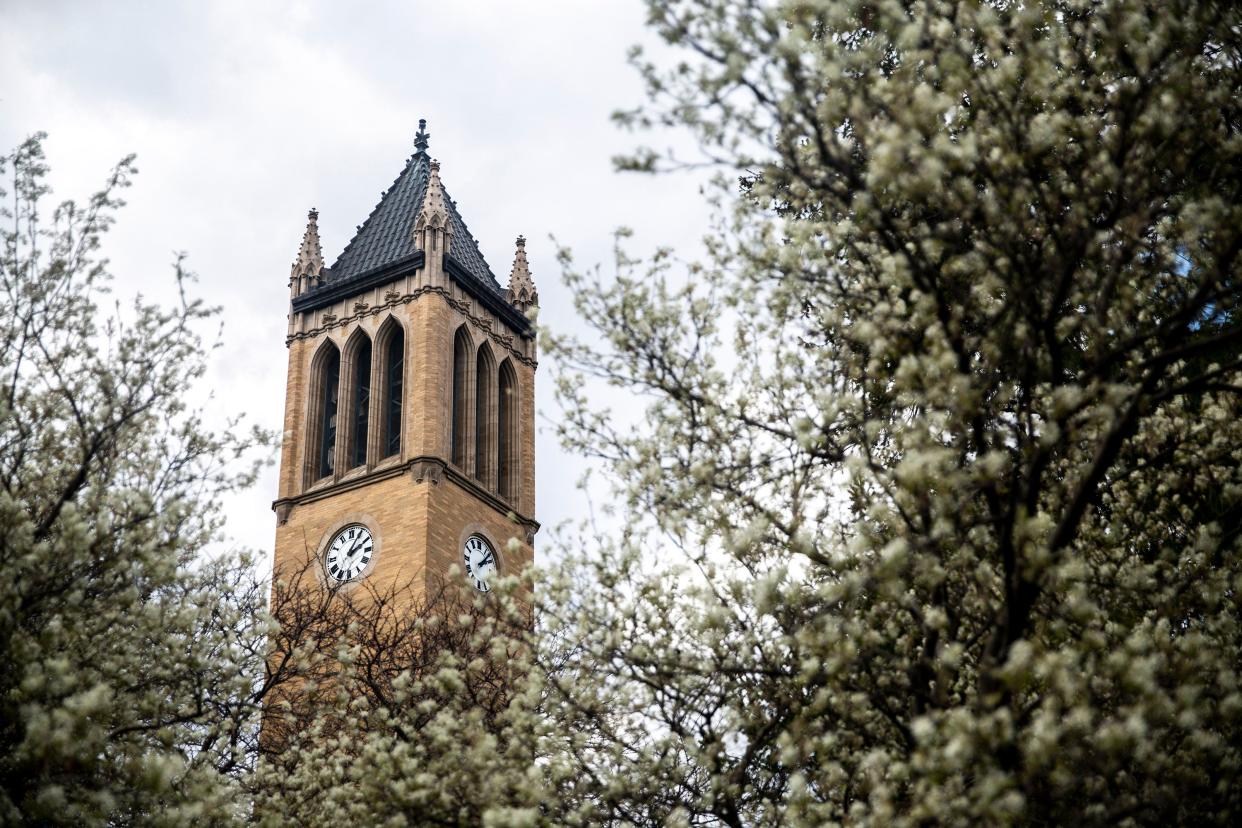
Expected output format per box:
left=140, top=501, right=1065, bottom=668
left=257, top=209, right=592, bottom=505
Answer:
left=0, top=135, right=267, bottom=824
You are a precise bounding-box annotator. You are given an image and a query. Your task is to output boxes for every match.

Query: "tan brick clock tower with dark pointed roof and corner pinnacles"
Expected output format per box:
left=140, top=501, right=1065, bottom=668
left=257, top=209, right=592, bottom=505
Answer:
left=273, top=120, right=539, bottom=597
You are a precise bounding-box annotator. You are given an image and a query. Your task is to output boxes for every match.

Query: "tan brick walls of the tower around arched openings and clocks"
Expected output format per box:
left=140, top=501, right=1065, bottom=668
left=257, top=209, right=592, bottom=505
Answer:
left=274, top=272, right=535, bottom=603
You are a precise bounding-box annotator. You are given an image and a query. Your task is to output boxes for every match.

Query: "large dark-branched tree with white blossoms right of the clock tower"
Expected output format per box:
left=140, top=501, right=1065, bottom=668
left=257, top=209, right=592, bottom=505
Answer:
left=540, top=0, right=1242, bottom=826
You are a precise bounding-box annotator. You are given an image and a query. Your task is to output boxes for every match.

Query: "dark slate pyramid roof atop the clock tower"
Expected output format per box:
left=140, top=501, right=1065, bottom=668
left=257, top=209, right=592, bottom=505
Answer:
left=324, top=151, right=504, bottom=295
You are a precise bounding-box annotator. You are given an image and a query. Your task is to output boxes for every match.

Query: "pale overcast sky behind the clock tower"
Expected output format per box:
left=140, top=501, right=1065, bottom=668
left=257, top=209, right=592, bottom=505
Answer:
left=0, top=0, right=705, bottom=561
